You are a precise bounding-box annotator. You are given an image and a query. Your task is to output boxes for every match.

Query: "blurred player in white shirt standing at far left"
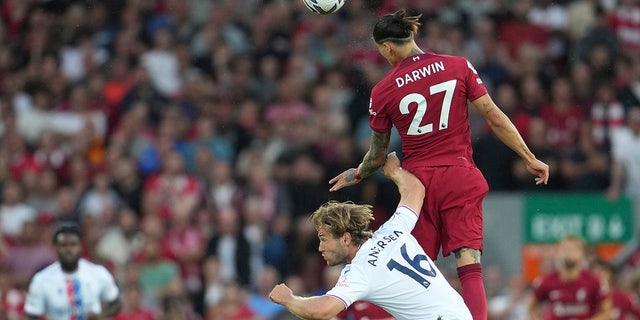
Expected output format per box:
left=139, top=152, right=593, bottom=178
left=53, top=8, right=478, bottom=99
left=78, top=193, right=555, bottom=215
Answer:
left=24, top=225, right=121, bottom=320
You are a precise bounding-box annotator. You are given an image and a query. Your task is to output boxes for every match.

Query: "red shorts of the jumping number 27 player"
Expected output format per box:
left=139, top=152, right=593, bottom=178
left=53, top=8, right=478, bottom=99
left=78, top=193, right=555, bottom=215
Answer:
left=411, top=166, right=489, bottom=260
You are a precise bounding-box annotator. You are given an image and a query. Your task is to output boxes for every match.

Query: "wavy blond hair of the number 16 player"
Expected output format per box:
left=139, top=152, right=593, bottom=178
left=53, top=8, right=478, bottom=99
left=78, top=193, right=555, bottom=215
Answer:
left=311, top=200, right=374, bottom=245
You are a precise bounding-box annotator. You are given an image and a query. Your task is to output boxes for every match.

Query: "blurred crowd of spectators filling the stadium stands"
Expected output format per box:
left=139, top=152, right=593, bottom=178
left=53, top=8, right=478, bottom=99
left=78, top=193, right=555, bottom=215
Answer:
left=0, top=0, right=640, bottom=320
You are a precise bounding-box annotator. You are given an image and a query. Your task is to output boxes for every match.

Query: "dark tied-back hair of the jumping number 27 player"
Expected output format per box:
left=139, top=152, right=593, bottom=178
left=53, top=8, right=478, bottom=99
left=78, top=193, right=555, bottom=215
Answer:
left=373, top=9, right=422, bottom=45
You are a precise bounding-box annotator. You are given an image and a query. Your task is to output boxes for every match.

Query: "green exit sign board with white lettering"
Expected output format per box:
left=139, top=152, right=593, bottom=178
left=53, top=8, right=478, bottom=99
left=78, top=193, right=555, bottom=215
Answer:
left=524, top=193, right=634, bottom=243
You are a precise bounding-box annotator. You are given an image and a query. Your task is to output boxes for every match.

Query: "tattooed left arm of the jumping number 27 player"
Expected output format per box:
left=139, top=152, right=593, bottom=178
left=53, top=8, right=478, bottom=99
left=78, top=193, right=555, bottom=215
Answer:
left=329, top=131, right=391, bottom=191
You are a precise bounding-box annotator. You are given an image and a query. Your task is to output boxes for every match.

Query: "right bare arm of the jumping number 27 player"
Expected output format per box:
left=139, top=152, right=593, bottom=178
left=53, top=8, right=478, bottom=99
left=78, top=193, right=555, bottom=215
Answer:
left=473, top=94, right=549, bottom=184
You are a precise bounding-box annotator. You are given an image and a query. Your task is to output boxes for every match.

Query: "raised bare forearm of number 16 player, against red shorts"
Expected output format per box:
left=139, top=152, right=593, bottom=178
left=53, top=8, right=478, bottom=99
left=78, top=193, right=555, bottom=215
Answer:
left=382, top=152, right=425, bottom=212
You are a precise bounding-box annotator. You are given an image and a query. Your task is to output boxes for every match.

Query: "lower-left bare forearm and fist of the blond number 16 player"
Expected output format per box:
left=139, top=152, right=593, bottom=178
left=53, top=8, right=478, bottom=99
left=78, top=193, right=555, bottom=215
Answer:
left=269, top=284, right=344, bottom=319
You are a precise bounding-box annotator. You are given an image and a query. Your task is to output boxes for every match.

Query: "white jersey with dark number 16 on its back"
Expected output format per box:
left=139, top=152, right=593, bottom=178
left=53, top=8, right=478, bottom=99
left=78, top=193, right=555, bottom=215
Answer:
left=327, top=206, right=472, bottom=320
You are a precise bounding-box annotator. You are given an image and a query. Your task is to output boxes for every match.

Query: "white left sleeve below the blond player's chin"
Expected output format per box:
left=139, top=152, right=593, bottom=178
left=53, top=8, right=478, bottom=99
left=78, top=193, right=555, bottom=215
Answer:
left=325, top=265, right=369, bottom=309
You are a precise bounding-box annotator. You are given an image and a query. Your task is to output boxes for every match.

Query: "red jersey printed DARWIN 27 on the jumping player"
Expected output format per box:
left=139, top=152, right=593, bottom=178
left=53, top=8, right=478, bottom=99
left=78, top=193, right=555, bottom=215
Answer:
left=369, top=53, right=487, bottom=169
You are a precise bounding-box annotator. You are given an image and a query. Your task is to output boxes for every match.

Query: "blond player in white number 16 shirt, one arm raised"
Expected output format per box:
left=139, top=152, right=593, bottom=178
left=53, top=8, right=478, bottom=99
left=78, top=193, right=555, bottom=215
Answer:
left=269, top=153, right=472, bottom=320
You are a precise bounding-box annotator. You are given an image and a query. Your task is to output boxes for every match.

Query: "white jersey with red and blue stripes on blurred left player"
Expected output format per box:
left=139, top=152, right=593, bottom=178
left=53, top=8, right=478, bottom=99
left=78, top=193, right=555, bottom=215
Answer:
left=24, top=259, right=119, bottom=320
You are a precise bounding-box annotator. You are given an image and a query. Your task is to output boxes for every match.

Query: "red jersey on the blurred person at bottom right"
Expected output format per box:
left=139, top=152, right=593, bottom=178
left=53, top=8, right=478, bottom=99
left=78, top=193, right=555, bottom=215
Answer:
left=533, top=270, right=606, bottom=320
